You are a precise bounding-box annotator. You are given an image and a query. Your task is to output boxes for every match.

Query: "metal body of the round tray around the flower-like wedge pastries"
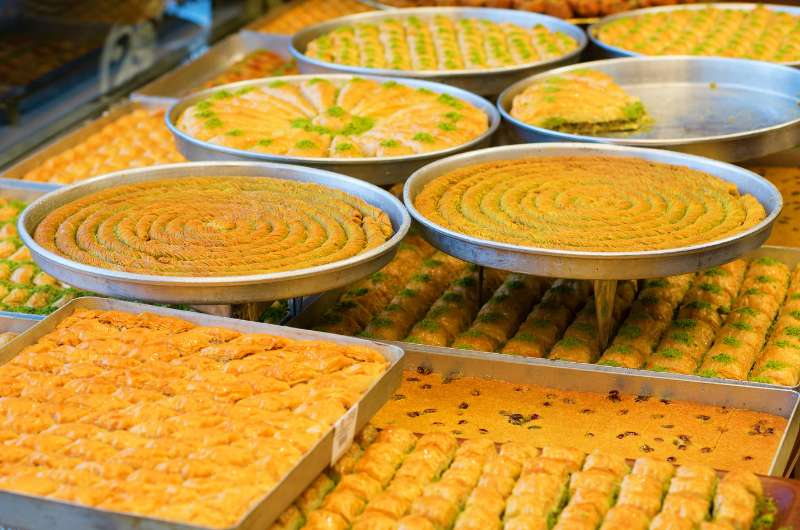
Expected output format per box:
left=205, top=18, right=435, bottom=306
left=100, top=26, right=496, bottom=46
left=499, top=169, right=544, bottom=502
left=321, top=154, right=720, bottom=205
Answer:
left=166, top=74, right=500, bottom=186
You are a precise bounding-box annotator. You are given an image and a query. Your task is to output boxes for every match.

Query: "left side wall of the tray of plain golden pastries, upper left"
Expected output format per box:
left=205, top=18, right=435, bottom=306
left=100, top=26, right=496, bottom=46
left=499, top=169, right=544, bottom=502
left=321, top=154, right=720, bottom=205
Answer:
left=0, top=99, right=165, bottom=179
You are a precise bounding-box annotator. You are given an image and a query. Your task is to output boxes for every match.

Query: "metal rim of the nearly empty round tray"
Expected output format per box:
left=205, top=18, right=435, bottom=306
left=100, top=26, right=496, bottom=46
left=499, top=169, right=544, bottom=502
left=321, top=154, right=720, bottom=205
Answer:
left=497, top=55, right=800, bottom=148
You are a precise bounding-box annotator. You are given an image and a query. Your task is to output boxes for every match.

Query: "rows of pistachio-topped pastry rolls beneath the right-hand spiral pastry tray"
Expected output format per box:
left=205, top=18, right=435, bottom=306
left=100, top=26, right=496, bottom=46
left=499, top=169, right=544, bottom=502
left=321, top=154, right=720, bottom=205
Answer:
left=296, top=231, right=800, bottom=387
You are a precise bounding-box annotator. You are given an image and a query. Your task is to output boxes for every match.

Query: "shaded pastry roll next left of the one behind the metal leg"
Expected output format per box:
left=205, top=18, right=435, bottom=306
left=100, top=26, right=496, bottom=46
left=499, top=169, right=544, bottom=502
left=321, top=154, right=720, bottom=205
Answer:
left=501, top=280, right=591, bottom=357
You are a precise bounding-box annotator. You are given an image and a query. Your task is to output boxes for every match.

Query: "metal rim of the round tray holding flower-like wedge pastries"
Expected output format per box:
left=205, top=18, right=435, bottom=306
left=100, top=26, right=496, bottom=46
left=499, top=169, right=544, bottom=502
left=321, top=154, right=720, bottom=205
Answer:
left=164, top=73, right=501, bottom=166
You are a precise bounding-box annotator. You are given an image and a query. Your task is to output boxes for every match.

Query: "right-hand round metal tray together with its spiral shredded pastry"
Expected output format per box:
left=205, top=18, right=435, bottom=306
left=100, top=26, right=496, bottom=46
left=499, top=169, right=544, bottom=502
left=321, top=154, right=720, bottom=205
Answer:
left=404, top=143, right=782, bottom=280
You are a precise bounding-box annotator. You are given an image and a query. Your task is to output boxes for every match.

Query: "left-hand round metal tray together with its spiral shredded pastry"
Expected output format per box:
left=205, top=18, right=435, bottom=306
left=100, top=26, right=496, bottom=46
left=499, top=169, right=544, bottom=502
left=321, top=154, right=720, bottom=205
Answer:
left=19, top=162, right=410, bottom=304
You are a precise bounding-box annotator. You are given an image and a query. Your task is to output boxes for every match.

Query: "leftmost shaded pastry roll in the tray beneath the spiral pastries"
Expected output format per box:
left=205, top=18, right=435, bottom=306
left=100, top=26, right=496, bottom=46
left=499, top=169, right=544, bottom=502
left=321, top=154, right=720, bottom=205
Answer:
left=314, top=235, right=434, bottom=335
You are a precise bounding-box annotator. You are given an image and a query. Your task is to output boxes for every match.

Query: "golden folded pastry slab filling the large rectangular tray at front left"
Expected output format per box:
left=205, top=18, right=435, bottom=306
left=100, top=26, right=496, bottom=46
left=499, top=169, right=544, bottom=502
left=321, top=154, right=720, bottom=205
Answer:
left=0, top=307, right=390, bottom=528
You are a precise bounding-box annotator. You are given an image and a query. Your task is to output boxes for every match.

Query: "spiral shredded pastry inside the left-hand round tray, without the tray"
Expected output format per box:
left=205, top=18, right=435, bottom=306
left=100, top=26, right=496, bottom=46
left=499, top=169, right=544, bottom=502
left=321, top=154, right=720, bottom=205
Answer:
left=34, top=177, right=393, bottom=276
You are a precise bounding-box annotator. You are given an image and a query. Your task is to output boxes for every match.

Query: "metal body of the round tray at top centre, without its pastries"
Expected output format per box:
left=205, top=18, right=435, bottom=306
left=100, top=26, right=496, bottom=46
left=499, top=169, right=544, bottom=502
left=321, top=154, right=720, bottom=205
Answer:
left=289, top=7, right=588, bottom=96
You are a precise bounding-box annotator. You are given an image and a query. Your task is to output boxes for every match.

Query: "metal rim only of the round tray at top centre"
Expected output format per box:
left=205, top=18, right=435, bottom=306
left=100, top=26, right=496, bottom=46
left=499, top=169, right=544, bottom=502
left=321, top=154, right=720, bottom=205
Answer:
left=289, top=7, right=589, bottom=79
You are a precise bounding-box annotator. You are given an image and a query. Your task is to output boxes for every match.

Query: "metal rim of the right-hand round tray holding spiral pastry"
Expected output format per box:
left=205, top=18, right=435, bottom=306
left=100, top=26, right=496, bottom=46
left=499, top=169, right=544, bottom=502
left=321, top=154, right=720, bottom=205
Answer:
left=403, top=142, right=783, bottom=266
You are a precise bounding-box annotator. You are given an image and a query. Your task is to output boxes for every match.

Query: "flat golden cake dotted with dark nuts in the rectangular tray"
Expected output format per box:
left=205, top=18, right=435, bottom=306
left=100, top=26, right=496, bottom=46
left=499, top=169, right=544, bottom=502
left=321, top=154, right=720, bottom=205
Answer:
left=372, top=367, right=788, bottom=474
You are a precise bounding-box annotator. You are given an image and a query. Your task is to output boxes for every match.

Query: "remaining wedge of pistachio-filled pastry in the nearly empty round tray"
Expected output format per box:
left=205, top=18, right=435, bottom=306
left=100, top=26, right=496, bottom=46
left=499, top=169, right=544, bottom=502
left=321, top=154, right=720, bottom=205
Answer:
left=511, top=69, right=648, bottom=136
